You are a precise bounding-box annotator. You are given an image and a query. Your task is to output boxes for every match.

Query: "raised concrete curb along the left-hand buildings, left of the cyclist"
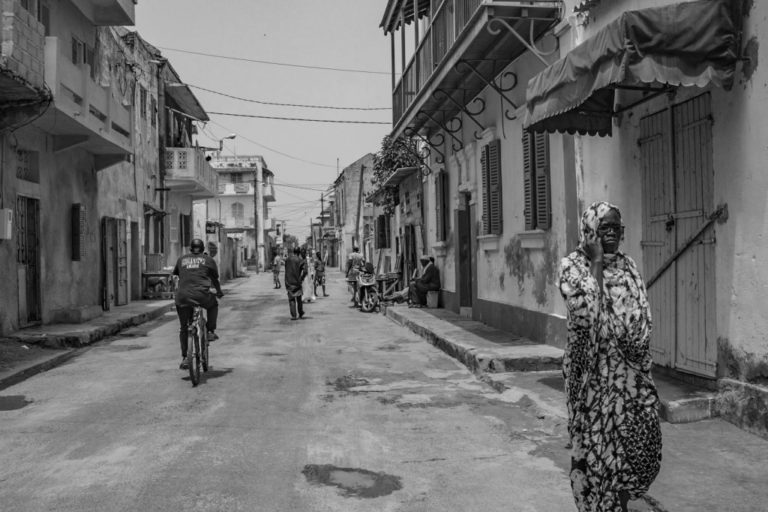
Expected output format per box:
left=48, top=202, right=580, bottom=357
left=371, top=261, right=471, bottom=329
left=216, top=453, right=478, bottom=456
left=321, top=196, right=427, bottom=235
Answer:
left=5, top=301, right=173, bottom=348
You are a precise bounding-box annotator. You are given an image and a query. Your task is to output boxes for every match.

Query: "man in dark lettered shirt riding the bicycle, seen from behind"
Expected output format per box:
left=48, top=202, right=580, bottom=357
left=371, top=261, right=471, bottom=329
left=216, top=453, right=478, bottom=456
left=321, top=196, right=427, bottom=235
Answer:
left=173, top=238, right=224, bottom=370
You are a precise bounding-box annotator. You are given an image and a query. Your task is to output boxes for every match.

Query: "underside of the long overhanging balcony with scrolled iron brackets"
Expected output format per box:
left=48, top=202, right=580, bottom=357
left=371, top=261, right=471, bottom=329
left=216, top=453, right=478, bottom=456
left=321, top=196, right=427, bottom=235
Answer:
left=391, top=0, right=563, bottom=137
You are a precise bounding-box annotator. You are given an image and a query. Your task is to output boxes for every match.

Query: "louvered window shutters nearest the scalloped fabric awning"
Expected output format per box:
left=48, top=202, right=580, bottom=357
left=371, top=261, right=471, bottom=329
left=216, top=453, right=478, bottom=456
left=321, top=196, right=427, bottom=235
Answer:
left=523, top=131, right=552, bottom=230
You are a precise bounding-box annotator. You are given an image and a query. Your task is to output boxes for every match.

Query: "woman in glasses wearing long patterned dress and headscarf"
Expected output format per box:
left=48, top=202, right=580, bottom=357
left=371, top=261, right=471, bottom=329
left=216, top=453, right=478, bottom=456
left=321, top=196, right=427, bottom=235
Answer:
left=560, top=202, right=661, bottom=512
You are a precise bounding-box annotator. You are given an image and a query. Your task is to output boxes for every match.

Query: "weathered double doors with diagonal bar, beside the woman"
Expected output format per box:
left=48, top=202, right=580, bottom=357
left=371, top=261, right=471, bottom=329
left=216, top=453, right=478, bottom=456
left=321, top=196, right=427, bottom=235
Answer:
left=639, top=93, right=717, bottom=377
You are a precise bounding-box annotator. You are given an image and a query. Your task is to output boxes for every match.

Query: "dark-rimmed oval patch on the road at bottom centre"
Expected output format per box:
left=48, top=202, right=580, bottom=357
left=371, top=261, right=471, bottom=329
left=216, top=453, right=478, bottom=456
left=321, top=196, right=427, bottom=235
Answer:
left=301, top=464, right=403, bottom=498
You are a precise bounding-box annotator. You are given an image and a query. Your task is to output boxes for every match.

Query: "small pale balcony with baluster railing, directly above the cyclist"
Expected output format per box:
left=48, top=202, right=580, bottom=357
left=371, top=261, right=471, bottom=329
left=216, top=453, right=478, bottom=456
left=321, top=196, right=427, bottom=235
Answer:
left=165, top=148, right=219, bottom=199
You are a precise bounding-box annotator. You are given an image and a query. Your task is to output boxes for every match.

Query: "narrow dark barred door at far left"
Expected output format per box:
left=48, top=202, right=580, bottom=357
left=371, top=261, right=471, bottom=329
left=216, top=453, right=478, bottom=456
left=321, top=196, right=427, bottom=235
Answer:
left=16, top=196, right=41, bottom=327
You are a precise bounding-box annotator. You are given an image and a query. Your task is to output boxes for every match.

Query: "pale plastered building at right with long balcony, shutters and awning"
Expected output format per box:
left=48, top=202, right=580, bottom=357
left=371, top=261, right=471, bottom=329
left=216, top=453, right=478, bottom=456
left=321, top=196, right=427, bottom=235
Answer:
left=382, top=0, right=768, bottom=434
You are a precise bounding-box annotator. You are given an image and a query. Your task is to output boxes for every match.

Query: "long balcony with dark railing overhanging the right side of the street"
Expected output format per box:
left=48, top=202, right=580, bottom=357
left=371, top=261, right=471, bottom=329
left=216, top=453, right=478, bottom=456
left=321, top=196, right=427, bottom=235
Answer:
left=382, top=0, right=563, bottom=135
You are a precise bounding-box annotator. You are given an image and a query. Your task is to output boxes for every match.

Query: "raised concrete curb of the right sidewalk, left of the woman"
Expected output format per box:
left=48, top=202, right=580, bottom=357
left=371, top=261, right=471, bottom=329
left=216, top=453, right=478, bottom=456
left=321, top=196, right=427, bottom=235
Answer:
left=384, top=307, right=563, bottom=373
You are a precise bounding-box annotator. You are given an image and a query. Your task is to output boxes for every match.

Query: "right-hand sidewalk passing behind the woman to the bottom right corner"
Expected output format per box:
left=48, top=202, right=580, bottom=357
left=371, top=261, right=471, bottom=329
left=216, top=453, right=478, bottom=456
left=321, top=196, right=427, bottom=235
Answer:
left=385, top=305, right=768, bottom=512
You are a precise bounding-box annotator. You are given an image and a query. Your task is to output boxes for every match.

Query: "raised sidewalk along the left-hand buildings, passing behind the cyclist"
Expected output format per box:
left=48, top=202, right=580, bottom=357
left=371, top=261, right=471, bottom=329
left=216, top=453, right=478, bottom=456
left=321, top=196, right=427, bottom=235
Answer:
left=0, top=279, right=244, bottom=390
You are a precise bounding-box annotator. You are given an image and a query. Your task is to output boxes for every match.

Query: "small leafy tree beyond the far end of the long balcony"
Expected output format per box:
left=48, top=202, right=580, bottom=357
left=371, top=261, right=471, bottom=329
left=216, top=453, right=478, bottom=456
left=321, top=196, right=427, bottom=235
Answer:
left=371, top=135, right=423, bottom=215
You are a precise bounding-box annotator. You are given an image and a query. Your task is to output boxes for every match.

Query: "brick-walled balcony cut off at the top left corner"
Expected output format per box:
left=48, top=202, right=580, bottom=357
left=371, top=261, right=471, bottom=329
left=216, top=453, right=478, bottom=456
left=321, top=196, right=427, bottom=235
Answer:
left=0, top=0, right=47, bottom=103
